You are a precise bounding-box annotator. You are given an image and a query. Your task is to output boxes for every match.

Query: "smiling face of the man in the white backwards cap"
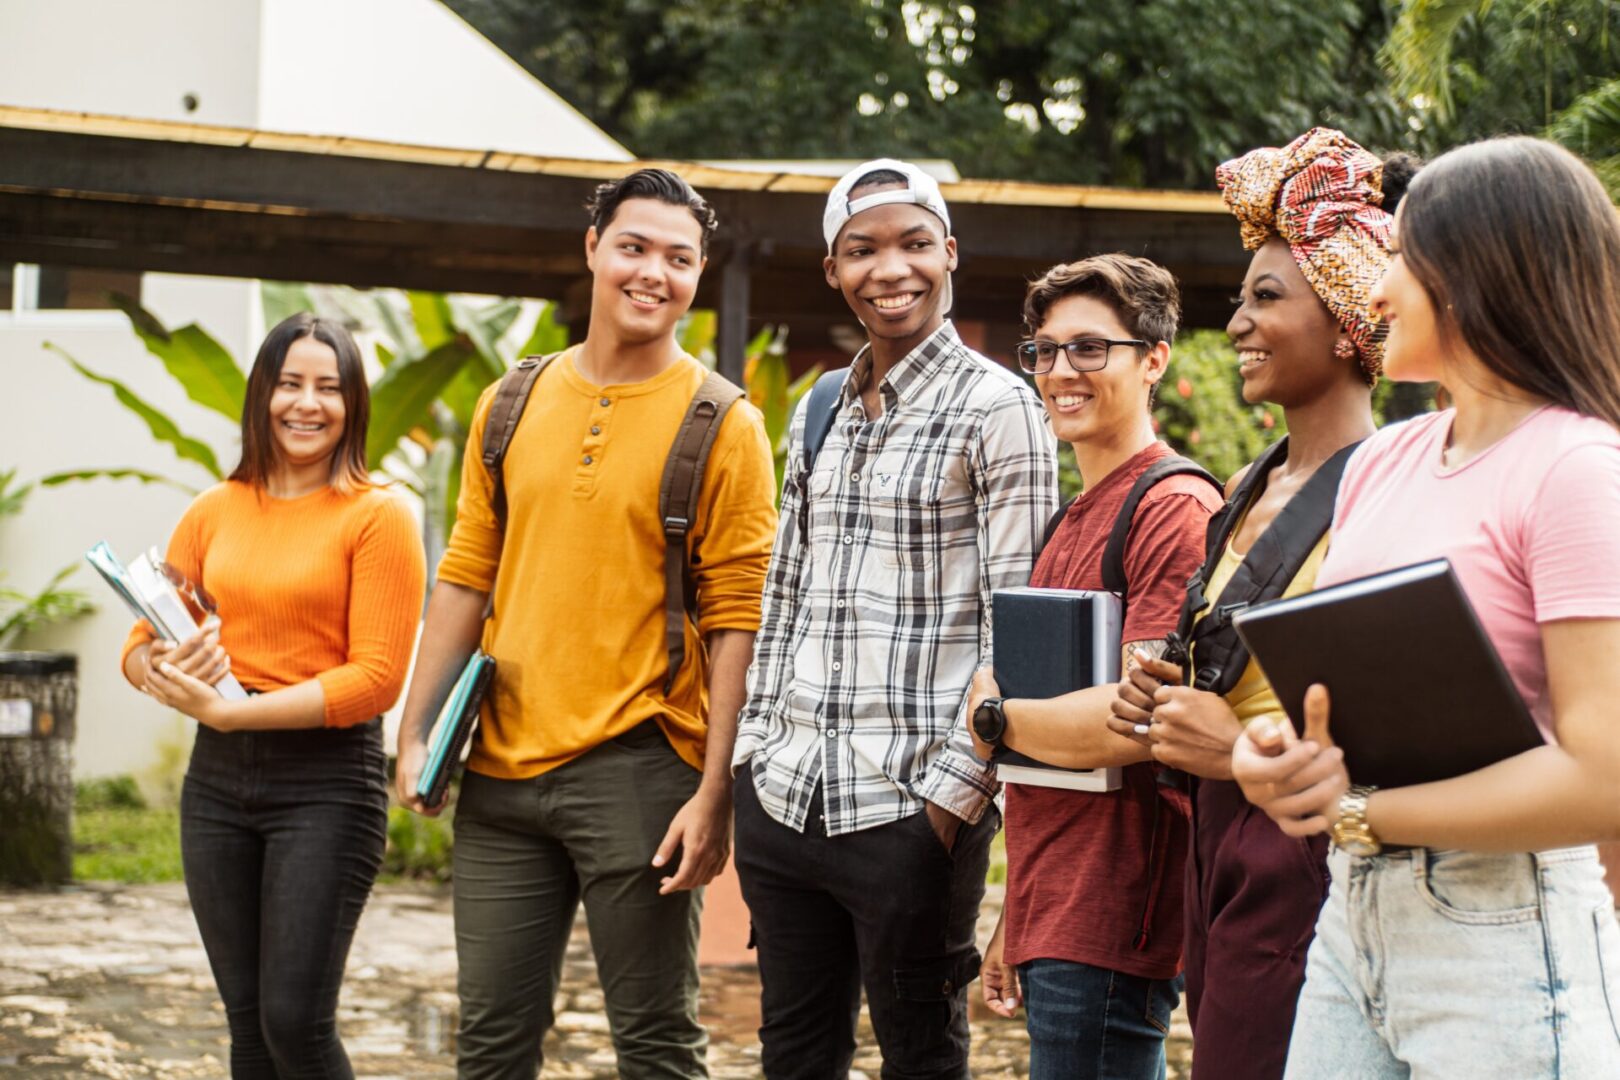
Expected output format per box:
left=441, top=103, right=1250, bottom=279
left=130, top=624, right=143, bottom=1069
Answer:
left=823, top=185, right=956, bottom=348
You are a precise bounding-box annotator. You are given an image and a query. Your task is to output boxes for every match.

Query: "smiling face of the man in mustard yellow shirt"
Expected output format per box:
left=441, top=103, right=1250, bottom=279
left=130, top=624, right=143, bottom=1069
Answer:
left=585, top=199, right=705, bottom=343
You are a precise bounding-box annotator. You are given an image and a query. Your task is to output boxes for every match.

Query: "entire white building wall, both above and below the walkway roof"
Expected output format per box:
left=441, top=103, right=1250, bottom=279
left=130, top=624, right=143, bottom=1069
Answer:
left=0, top=0, right=630, bottom=786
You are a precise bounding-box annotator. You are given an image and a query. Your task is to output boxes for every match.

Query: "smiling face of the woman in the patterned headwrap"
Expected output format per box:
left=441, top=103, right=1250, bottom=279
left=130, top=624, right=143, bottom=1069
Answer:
left=1226, top=238, right=1361, bottom=408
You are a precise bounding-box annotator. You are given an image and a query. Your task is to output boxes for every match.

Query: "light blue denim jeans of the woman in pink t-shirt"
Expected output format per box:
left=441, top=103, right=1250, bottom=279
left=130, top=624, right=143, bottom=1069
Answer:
left=1286, top=847, right=1620, bottom=1080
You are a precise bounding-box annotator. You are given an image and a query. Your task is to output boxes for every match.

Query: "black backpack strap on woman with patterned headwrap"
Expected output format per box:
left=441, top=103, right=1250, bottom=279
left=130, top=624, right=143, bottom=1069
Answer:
left=1191, top=444, right=1361, bottom=693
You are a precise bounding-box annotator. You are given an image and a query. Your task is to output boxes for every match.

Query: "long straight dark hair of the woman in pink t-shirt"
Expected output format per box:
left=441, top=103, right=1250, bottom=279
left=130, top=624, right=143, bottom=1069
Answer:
left=1398, top=136, right=1620, bottom=426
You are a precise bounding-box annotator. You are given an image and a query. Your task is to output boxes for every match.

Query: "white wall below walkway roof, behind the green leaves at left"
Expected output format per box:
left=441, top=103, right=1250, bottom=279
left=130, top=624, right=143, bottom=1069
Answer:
left=0, top=274, right=259, bottom=786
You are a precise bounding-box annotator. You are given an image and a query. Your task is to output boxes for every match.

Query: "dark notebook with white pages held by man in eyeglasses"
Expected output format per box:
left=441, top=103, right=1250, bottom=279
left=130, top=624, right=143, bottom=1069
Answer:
left=990, top=588, right=1121, bottom=792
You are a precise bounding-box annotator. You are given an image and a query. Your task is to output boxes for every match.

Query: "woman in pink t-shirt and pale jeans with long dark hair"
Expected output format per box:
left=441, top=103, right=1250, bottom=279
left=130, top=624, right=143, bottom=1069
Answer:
left=1233, top=138, right=1620, bottom=1078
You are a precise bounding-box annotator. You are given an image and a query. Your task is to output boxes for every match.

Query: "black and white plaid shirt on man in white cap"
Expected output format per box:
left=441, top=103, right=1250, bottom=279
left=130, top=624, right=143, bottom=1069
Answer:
left=732, top=322, right=1058, bottom=836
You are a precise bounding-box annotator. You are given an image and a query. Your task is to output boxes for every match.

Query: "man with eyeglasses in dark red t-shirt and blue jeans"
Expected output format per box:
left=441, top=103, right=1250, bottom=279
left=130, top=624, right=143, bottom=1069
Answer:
left=969, top=254, right=1221, bottom=1080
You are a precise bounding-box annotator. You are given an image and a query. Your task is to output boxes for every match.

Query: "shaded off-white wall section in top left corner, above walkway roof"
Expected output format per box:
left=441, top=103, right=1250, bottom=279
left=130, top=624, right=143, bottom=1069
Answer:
left=0, top=0, right=260, bottom=126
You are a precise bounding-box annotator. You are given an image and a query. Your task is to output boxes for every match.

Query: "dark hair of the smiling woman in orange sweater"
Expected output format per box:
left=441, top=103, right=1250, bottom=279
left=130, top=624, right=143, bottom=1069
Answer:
left=230, top=311, right=371, bottom=494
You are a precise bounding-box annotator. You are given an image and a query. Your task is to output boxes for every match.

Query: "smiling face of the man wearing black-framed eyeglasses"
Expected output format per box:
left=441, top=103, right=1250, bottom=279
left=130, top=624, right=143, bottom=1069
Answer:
left=1034, top=296, right=1170, bottom=444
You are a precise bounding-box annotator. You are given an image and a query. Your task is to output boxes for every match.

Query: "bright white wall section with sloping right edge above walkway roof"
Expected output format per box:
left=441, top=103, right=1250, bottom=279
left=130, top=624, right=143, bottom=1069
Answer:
left=259, top=0, right=630, bottom=162
